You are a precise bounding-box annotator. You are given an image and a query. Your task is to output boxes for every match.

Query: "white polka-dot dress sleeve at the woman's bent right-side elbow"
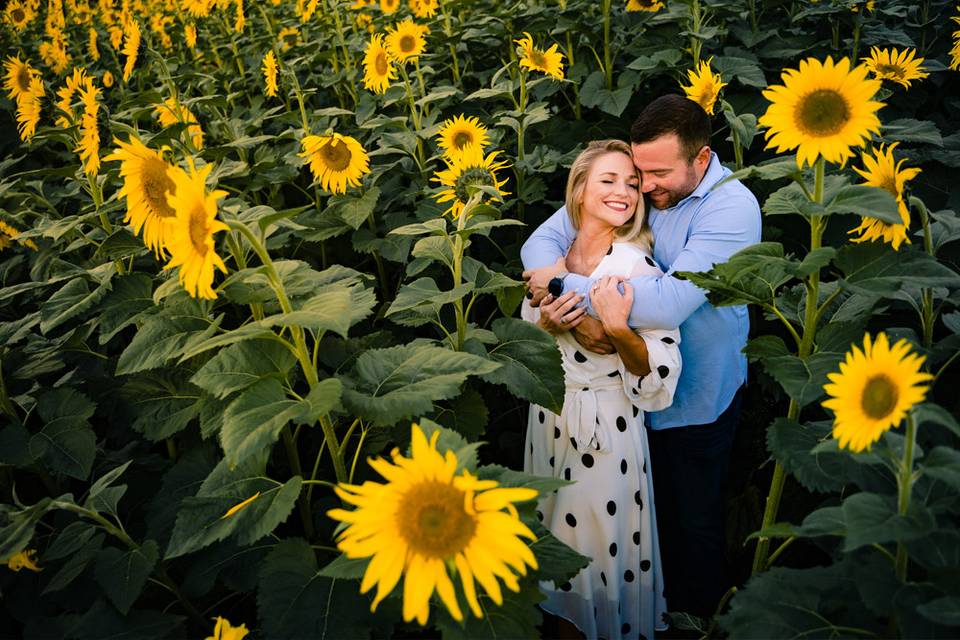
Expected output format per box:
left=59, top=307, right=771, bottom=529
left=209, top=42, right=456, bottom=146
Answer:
left=619, top=329, right=682, bottom=411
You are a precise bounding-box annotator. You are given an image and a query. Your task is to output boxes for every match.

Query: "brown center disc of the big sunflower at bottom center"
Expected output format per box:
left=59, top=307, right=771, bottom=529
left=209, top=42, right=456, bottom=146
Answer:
left=397, top=482, right=477, bottom=559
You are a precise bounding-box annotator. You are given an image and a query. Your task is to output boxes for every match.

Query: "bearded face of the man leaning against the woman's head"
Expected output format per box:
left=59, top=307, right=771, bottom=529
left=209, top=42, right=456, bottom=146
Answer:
left=631, top=133, right=710, bottom=209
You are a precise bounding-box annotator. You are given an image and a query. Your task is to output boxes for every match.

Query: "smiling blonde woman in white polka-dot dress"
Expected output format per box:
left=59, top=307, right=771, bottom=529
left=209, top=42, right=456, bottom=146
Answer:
left=522, top=140, right=680, bottom=640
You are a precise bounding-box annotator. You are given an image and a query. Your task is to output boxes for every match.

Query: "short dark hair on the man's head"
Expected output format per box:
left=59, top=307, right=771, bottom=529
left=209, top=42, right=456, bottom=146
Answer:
left=630, top=94, right=710, bottom=162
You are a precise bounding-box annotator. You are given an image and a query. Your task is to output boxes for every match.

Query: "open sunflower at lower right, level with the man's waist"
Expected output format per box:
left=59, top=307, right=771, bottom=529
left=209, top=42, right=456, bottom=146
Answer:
left=823, top=332, right=933, bottom=452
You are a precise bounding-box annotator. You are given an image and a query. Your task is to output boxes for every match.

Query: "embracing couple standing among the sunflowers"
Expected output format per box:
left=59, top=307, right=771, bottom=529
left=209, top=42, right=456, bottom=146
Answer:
left=522, top=95, right=760, bottom=640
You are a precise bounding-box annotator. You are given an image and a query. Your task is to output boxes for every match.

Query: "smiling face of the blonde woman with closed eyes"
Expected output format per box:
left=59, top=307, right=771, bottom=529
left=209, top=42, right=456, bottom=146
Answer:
left=580, top=151, right=640, bottom=227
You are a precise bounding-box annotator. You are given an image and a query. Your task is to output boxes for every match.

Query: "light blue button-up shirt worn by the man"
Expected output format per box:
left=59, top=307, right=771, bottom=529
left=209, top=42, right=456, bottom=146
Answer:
left=520, top=153, right=760, bottom=429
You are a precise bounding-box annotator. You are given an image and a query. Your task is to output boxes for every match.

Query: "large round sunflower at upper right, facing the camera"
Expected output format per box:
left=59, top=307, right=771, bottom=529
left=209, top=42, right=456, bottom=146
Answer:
left=759, top=56, right=884, bottom=167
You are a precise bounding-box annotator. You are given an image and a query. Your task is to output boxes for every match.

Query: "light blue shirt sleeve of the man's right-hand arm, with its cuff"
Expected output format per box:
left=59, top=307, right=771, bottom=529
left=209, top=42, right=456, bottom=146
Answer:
left=564, top=194, right=760, bottom=329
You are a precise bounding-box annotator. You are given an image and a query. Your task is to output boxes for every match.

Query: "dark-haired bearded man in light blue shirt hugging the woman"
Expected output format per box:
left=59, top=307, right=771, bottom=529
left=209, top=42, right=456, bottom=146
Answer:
left=521, top=95, right=760, bottom=617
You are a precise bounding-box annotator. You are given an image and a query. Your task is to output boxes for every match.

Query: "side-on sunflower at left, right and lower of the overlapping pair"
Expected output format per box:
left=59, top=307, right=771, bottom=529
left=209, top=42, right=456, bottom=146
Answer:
left=163, top=161, right=229, bottom=300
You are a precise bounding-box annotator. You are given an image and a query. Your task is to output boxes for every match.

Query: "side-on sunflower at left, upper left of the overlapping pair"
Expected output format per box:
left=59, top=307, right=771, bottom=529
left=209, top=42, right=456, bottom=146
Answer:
left=104, top=136, right=176, bottom=258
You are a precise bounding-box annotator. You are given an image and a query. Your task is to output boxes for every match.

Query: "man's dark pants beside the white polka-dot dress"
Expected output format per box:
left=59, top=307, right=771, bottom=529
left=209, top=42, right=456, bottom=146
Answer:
left=647, top=387, right=743, bottom=617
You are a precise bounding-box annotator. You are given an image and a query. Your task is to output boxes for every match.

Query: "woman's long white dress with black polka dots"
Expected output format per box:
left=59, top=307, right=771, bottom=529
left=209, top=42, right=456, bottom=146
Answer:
left=522, top=242, right=680, bottom=640
